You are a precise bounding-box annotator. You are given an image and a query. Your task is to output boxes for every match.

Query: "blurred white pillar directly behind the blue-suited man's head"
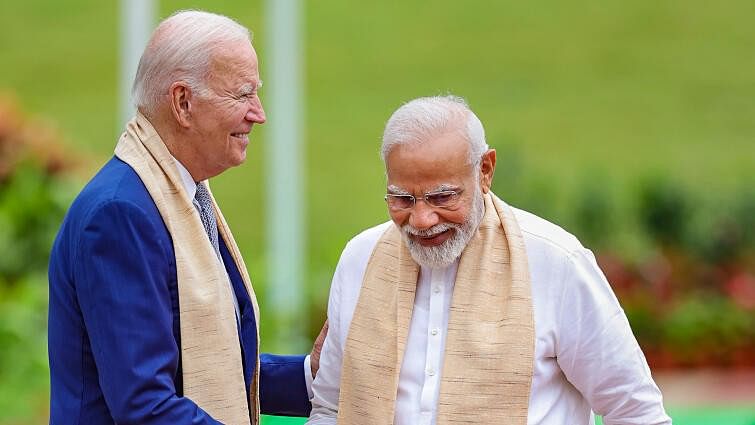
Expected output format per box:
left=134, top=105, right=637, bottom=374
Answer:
left=117, top=0, right=156, bottom=132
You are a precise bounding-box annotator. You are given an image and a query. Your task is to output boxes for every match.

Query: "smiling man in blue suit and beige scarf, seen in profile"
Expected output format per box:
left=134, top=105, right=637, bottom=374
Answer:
left=49, top=11, right=325, bottom=425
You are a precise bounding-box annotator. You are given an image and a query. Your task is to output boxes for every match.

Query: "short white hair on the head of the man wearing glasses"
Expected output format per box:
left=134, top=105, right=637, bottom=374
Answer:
left=380, top=95, right=488, bottom=165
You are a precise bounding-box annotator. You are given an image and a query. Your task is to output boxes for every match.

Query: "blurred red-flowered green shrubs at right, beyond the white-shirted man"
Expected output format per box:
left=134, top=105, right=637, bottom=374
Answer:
left=598, top=181, right=755, bottom=368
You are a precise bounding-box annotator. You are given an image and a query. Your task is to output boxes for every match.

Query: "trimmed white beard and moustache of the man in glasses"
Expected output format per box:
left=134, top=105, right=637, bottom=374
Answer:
left=401, top=184, right=485, bottom=269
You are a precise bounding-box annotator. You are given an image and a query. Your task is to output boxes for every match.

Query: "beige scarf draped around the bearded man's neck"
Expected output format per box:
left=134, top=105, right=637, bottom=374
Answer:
left=338, top=194, right=535, bottom=425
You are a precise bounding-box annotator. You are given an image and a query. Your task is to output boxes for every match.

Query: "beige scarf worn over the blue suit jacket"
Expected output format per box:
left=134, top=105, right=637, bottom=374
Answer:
left=115, top=114, right=259, bottom=425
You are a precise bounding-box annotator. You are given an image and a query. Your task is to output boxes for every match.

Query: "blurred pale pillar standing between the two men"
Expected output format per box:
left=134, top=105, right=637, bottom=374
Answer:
left=261, top=0, right=309, bottom=351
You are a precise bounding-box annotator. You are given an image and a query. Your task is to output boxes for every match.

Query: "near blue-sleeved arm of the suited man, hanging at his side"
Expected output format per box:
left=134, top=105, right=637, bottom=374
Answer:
left=73, top=202, right=218, bottom=425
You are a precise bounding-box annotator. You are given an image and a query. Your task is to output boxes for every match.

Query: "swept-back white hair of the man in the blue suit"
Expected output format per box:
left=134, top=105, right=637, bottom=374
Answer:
left=131, top=10, right=252, bottom=115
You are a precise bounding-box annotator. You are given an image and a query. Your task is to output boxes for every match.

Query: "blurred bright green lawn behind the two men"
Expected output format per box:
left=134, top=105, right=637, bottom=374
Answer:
left=0, top=0, right=755, bottom=425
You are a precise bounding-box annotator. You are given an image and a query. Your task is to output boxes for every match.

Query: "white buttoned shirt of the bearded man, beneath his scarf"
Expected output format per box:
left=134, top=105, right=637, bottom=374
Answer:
left=307, top=209, right=671, bottom=425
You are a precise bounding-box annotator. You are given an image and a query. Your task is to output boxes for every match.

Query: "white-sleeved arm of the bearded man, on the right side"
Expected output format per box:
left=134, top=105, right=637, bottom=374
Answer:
left=557, top=249, right=671, bottom=425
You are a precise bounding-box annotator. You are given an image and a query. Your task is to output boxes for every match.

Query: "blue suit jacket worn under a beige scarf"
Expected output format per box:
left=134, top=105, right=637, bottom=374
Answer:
left=48, top=158, right=310, bottom=425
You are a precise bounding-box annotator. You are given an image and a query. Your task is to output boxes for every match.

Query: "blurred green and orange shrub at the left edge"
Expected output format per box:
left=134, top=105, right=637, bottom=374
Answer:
left=0, top=93, right=72, bottom=423
